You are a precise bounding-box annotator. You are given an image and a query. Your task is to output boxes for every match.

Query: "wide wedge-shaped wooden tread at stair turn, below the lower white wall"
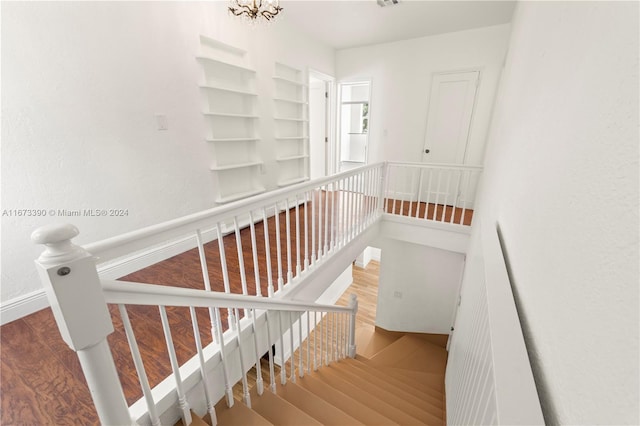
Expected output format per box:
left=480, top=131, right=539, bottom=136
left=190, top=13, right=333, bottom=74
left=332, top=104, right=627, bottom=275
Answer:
left=369, top=335, right=447, bottom=373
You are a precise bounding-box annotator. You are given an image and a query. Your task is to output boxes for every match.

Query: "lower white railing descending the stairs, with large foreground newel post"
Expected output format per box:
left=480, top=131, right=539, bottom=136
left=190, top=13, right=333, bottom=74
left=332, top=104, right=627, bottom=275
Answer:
left=34, top=225, right=357, bottom=425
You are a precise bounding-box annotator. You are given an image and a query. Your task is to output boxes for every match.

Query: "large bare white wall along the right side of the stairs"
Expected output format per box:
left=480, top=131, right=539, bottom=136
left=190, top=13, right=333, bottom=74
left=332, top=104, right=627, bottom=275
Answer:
left=479, top=2, right=640, bottom=424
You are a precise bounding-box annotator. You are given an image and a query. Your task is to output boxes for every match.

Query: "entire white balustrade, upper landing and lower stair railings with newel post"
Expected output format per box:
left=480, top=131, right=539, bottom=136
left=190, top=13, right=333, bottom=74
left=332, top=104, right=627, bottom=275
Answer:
left=32, top=163, right=480, bottom=425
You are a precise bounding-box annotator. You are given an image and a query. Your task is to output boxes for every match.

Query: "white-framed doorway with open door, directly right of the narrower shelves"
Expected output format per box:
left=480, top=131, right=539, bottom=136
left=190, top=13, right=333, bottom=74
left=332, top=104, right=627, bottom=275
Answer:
left=309, top=70, right=335, bottom=179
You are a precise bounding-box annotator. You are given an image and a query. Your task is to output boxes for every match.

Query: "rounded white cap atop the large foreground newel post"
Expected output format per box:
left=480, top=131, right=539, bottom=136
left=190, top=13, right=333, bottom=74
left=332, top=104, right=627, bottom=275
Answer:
left=31, top=223, right=88, bottom=265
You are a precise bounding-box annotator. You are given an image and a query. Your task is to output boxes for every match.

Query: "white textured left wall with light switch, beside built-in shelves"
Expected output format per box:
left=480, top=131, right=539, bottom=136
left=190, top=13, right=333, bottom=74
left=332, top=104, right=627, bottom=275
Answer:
left=0, top=2, right=334, bottom=306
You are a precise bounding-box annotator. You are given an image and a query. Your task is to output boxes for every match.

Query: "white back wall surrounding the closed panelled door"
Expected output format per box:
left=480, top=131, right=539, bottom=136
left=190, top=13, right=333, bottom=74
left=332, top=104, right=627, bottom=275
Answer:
left=336, top=25, right=510, bottom=164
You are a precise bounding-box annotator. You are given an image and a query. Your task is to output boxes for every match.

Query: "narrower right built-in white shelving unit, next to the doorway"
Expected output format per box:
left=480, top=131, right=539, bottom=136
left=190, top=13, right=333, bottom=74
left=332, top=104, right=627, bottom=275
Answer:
left=273, top=62, right=309, bottom=187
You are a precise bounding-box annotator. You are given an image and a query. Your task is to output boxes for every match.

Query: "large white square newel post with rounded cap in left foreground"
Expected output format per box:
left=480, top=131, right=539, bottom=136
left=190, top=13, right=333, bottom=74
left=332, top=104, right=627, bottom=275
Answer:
left=31, top=224, right=134, bottom=425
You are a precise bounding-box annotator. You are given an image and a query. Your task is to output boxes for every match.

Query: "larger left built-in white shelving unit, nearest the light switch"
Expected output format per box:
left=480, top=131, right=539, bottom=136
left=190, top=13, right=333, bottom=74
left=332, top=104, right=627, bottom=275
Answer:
left=196, top=36, right=265, bottom=203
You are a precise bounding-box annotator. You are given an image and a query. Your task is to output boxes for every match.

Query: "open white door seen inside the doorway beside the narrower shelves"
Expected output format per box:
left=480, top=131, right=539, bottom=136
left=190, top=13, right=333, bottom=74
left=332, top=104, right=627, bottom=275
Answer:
left=309, top=77, right=329, bottom=179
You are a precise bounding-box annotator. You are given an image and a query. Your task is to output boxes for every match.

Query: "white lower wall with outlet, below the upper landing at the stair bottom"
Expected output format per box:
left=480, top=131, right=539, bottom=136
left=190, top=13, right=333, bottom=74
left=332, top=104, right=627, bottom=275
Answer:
left=376, top=238, right=464, bottom=334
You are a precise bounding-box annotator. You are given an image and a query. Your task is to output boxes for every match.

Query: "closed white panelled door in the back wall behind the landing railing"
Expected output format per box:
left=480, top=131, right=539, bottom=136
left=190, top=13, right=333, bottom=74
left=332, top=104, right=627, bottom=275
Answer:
left=420, top=71, right=480, bottom=205
